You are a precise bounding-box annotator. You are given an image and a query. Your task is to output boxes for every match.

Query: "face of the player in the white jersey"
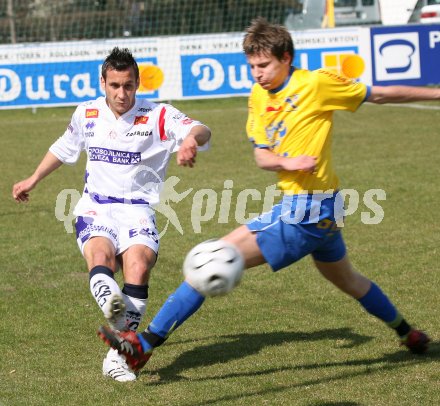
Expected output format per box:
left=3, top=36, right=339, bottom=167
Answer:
left=101, top=68, right=139, bottom=118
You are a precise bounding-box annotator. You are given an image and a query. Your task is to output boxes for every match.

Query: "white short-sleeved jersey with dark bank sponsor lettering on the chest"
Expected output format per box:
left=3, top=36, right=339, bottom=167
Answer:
left=49, top=97, right=208, bottom=205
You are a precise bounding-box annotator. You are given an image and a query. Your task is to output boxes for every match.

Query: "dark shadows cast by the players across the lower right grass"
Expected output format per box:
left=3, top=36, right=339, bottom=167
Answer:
left=143, top=328, right=440, bottom=406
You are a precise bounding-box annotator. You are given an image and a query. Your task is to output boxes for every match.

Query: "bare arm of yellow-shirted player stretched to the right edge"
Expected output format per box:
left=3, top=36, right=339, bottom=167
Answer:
left=367, top=86, right=440, bottom=104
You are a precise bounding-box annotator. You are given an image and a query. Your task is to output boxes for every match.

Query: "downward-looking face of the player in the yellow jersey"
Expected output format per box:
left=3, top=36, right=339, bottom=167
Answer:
left=247, top=52, right=291, bottom=90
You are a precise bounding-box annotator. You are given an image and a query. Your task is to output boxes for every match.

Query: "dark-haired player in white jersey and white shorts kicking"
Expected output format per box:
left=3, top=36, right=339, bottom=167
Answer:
left=12, top=48, right=211, bottom=382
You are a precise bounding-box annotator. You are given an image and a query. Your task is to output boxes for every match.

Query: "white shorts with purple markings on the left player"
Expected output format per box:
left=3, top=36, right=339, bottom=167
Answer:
left=73, top=195, right=159, bottom=255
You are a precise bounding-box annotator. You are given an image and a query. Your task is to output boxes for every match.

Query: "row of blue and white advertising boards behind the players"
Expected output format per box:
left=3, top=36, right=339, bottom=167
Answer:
left=0, top=24, right=440, bottom=109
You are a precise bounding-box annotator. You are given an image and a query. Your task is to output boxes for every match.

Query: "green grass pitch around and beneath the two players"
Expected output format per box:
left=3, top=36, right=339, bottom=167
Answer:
left=0, top=98, right=440, bottom=406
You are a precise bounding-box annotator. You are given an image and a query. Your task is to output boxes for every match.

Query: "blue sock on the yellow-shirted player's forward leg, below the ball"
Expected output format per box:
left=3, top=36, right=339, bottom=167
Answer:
left=138, top=282, right=205, bottom=352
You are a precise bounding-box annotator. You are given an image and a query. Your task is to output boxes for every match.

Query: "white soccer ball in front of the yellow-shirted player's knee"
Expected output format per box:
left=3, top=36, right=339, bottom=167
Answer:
left=183, top=240, right=244, bottom=296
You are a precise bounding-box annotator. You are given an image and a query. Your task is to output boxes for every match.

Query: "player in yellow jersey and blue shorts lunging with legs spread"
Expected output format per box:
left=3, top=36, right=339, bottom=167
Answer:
left=99, top=18, right=440, bottom=369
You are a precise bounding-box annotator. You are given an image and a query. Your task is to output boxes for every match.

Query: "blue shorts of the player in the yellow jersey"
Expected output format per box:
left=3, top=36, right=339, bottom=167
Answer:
left=247, top=196, right=346, bottom=271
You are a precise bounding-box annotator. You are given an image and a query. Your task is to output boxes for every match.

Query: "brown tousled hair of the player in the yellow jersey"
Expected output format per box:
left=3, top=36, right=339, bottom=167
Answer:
left=243, top=17, right=295, bottom=61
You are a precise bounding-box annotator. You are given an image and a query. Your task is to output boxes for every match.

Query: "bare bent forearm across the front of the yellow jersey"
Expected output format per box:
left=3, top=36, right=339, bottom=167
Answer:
left=254, top=148, right=316, bottom=173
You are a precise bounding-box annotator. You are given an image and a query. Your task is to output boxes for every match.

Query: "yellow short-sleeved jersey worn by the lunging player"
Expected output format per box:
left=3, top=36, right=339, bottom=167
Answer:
left=246, top=68, right=369, bottom=195
